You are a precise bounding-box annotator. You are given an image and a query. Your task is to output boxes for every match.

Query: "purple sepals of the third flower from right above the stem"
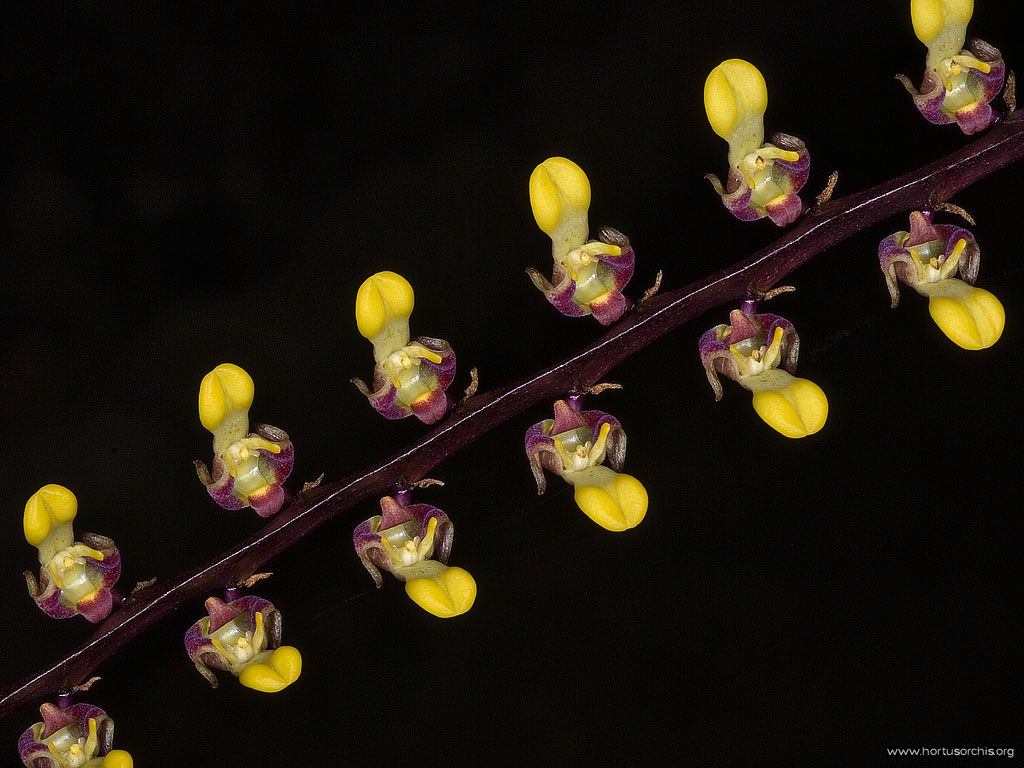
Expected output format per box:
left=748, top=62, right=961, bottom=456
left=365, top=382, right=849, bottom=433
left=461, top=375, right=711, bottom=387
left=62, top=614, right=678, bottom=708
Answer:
left=526, top=226, right=636, bottom=326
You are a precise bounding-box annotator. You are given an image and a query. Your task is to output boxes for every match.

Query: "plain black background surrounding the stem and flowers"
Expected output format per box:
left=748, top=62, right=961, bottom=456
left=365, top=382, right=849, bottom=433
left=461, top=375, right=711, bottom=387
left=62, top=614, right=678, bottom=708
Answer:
left=0, top=1, right=1024, bottom=766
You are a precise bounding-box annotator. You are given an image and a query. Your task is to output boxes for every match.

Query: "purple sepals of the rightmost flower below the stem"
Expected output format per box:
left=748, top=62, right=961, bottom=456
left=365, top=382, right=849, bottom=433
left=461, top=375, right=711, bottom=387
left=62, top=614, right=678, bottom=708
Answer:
left=879, top=211, right=981, bottom=307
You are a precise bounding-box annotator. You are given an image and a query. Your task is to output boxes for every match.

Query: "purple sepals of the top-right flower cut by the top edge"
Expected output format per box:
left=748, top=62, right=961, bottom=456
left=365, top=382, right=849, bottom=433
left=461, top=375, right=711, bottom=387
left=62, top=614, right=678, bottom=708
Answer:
left=899, top=39, right=1007, bottom=135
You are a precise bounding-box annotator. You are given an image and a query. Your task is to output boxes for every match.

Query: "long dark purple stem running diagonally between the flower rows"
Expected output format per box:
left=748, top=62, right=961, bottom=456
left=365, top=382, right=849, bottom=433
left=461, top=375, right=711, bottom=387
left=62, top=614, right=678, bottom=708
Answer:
left=0, top=111, right=1024, bottom=718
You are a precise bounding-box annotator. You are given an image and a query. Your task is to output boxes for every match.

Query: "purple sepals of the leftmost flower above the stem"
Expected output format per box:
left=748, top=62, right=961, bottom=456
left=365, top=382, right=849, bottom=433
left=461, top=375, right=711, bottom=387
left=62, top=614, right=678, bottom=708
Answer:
left=25, top=534, right=121, bottom=624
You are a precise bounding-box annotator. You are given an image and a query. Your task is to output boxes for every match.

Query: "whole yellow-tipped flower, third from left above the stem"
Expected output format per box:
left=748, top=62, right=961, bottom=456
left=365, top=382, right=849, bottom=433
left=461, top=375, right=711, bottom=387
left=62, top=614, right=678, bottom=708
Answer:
left=352, top=271, right=456, bottom=424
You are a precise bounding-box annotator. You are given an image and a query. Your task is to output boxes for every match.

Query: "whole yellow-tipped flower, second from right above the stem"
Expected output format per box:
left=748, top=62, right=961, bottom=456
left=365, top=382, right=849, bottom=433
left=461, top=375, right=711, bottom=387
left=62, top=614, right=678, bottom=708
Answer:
left=703, top=58, right=811, bottom=226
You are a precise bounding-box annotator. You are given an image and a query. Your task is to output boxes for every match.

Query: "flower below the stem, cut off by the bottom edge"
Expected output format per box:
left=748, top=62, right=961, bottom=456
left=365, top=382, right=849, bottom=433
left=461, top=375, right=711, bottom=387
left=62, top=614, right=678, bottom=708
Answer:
left=17, top=703, right=133, bottom=768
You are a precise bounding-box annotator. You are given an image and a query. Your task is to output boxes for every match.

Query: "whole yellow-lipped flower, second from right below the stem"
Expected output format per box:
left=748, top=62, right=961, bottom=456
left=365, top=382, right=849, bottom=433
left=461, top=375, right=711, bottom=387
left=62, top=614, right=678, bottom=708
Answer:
left=698, top=301, right=828, bottom=437
